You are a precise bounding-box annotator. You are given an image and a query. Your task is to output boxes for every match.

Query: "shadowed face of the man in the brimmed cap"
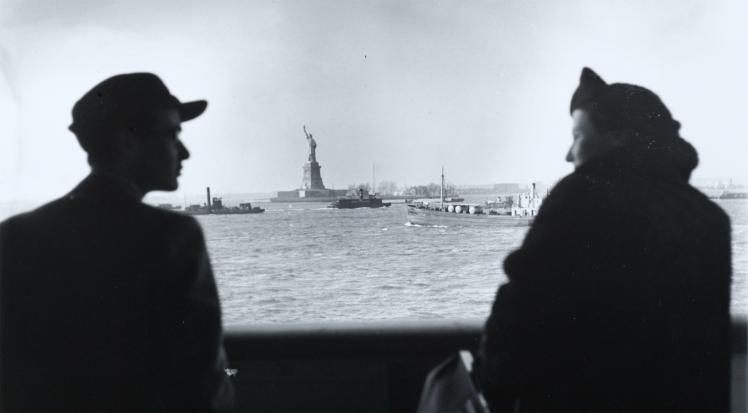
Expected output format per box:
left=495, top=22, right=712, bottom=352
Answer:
left=134, top=126, right=190, bottom=192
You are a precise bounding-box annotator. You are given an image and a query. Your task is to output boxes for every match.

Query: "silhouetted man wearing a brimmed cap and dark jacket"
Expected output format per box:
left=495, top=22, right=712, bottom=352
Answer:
left=0, top=73, right=233, bottom=411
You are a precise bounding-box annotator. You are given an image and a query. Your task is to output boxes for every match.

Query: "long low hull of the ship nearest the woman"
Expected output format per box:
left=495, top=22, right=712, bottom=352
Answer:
left=408, top=205, right=533, bottom=227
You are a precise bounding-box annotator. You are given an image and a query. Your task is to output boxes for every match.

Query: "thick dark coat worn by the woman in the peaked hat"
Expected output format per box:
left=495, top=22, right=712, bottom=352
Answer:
left=475, top=144, right=731, bottom=411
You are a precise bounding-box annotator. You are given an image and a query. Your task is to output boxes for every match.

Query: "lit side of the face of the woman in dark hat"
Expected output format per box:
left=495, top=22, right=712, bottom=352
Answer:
left=566, top=109, right=614, bottom=168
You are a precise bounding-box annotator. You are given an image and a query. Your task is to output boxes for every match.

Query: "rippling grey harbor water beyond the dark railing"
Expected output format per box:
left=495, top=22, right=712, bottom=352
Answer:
left=197, top=200, right=748, bottom=325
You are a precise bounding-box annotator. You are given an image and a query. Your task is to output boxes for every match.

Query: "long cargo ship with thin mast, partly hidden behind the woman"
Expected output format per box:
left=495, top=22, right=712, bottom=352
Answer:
left=407, top=168, right=542, bottom=226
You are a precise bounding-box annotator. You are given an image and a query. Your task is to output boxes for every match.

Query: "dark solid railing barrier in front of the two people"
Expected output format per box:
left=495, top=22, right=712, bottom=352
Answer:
left=226, top=318, right=748, bottom=412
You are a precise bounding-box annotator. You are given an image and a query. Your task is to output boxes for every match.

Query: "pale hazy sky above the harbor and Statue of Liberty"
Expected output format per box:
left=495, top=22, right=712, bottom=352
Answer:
left=0, top=0, right=748, bottom=202
